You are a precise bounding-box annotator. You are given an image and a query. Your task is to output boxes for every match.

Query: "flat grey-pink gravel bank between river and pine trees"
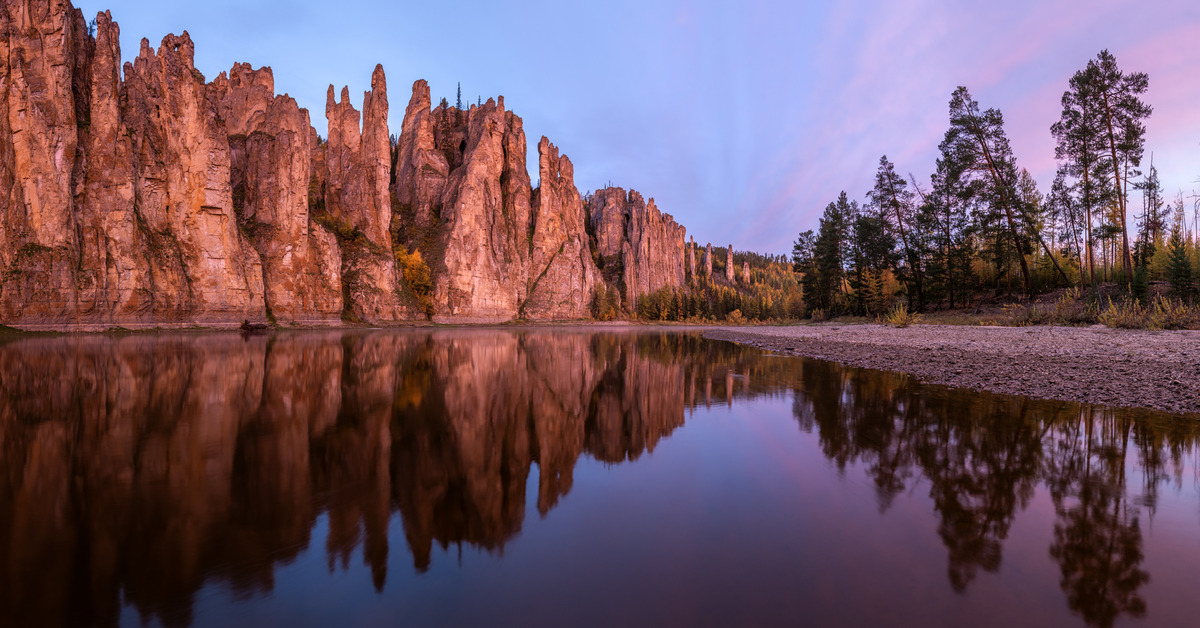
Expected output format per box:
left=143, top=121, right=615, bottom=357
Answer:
left=704, top=324, right=1200, bottom=414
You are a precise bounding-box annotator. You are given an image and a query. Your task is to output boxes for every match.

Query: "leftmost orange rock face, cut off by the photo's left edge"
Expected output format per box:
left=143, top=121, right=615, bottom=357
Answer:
left=0, top=0, right=90, bottom=323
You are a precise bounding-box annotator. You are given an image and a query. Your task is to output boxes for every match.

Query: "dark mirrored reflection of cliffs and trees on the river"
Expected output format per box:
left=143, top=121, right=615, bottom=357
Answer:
left=0, top=330, right=1198, bottom=626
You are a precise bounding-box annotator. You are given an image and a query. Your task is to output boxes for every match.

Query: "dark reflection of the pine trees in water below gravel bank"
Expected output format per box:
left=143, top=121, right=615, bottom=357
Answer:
left=793, top=363, right=1198, bottom=626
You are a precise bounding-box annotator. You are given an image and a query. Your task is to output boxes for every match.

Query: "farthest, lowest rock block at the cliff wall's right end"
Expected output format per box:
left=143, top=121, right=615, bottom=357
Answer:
left=588, top=187, right=695, bottom=306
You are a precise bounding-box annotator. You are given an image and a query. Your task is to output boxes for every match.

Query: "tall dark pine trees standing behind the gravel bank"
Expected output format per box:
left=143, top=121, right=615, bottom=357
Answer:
left=792, top=50, right=1200, bottom=315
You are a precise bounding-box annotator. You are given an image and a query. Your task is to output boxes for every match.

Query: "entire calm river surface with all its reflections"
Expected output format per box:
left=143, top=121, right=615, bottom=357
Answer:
left=0, top=329, right=1200, bottom=627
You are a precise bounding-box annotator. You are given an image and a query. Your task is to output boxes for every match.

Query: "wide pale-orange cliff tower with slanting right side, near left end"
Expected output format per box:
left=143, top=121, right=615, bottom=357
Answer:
left=122, top=31, right=265, bottom=323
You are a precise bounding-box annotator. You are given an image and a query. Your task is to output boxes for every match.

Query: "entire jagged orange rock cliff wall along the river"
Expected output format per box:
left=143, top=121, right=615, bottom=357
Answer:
left=0, top=0, right=710, bottom=328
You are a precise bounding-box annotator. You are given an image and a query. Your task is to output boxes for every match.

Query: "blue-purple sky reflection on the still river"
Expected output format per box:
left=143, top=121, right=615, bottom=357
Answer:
left=164, top=389, right=1200, bottom=627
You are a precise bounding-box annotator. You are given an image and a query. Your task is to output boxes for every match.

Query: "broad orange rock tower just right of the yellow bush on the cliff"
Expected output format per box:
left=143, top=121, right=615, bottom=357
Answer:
left=417, top=97, right=530, bottom=323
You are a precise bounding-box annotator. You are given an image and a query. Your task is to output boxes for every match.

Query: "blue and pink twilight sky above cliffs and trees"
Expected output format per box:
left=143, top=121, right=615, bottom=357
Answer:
left=74, top=0, right=1200, bottom=253
